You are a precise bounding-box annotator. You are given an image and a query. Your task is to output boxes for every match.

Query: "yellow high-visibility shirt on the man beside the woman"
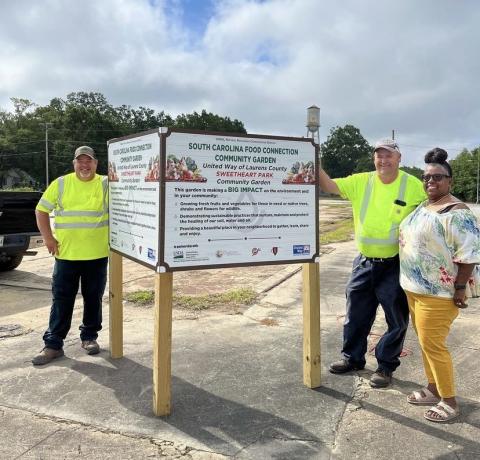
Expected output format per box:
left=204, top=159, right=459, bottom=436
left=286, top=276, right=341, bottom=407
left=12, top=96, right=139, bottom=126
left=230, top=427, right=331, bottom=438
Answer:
left=334, top=171, right=426, bottom=258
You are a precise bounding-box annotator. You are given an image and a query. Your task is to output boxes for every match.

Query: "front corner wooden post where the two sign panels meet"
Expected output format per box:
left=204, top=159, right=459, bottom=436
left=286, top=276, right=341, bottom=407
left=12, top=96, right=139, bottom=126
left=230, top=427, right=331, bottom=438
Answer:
left=153, top=273, right=173, bottom=415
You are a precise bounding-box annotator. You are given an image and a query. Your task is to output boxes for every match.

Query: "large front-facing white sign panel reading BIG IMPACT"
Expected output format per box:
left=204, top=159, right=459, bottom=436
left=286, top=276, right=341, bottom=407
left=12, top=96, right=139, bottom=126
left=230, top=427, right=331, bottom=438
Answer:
left=163, top=132, right=318, bottom=270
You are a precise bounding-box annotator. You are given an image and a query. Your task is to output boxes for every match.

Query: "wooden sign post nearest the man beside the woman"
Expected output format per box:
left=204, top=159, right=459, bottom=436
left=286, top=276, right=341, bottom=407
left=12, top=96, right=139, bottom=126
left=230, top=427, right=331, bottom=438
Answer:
left=303, top=263, right=321, bottom=388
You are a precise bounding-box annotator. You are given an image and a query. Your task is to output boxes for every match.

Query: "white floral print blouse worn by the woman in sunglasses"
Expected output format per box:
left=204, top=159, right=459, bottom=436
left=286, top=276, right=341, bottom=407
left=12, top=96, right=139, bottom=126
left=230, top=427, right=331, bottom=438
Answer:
left=399, top=201, right=480, bottom=298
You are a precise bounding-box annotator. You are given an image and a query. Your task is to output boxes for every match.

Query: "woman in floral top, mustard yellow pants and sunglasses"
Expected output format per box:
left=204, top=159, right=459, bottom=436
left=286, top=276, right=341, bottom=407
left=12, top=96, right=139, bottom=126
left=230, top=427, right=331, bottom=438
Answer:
left=400, top=148, right=480, bottom=422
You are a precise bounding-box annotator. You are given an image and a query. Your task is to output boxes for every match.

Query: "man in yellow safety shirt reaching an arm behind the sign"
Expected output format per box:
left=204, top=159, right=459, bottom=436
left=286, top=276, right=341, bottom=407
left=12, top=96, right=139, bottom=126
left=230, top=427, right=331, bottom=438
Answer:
left=319, top=140, right=426, bottom=388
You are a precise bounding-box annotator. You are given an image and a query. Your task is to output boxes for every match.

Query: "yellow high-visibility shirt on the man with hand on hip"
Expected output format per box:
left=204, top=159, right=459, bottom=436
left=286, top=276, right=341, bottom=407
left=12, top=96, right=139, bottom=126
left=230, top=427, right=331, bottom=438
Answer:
left=36, top=173, right=109, bottom=260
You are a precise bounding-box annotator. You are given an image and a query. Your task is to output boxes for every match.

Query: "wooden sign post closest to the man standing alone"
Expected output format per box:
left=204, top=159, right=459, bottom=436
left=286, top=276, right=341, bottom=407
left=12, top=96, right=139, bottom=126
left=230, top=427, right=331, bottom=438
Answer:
left=109, top=251, right=123, bottom=358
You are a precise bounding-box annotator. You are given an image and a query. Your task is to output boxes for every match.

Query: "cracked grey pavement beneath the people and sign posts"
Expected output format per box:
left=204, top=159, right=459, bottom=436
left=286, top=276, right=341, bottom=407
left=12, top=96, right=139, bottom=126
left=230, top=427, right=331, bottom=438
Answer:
left=0, top=242, right=480, bottom=460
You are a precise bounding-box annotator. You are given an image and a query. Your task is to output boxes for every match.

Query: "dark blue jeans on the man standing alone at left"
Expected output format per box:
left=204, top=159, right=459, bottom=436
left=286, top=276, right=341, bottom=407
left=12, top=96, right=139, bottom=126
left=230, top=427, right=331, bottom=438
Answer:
left=43, top=257, right=108, bottom=350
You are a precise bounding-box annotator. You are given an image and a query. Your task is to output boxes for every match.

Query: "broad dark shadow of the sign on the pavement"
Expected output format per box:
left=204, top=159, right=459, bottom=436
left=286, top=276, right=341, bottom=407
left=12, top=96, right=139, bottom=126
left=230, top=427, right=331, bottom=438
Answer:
left=71, top=358, right=327, bottom=459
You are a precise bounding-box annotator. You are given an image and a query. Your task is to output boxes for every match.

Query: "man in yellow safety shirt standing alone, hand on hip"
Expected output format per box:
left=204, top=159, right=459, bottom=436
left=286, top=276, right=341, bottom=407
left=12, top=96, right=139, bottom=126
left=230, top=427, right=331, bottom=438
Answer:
left=32, top=146, right=108, bottom=365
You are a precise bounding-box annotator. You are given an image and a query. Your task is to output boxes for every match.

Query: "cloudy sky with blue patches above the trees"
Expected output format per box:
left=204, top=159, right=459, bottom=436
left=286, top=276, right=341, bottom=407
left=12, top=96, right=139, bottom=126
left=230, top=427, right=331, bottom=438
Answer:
left=0, top=0, right=480, bottom=164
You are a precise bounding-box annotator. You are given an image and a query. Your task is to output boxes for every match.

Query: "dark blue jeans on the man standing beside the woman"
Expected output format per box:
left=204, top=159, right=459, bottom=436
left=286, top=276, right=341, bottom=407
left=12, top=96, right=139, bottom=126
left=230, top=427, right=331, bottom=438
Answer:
left=342, top=255, right=408, bottom=372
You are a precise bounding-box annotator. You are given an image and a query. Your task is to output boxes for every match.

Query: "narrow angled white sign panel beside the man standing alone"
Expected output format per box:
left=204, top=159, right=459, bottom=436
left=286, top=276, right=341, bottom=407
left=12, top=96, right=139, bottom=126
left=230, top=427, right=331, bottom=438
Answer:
left=108, top=132, right=160, bottom=267
